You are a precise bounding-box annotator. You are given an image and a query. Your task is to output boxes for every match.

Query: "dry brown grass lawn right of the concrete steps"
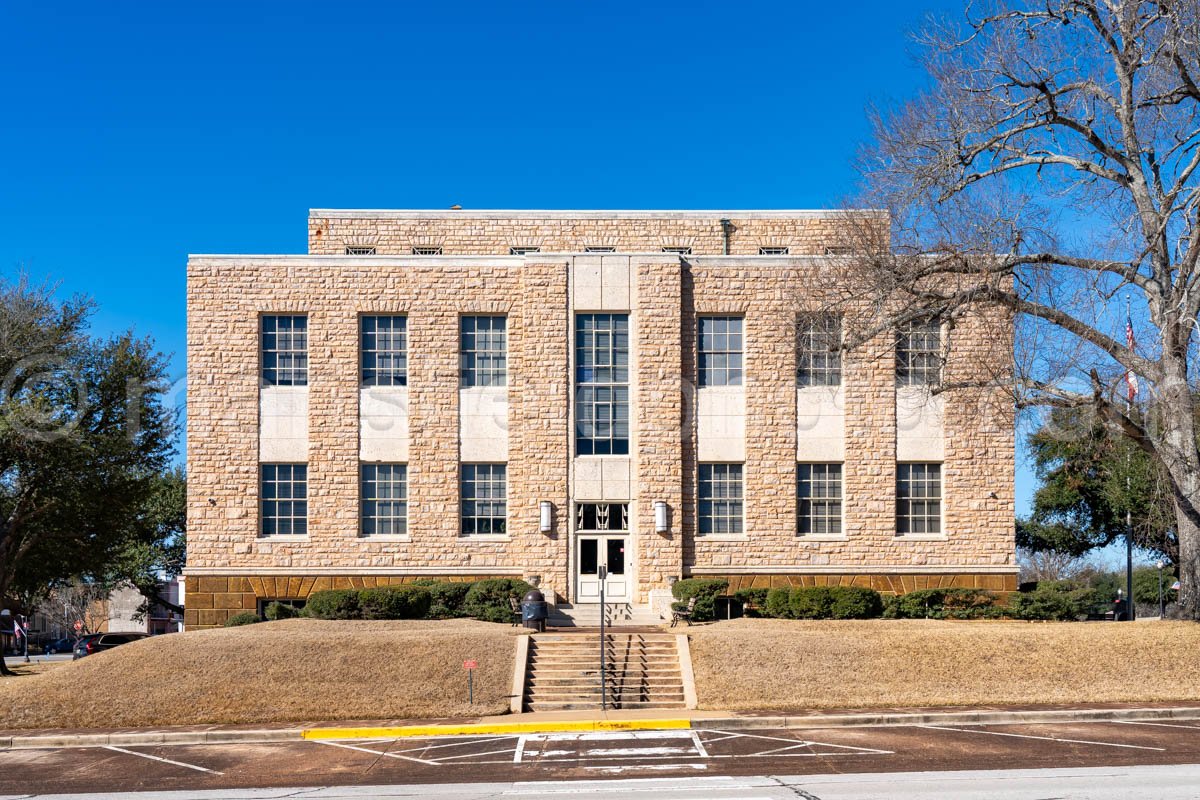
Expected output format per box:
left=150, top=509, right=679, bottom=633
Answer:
left=689, top=619, right=1200, bottom=710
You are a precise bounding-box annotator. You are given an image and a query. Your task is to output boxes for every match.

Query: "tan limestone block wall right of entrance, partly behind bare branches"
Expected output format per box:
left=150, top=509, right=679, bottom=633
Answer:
left=684, top=258, right=1015, bottom=585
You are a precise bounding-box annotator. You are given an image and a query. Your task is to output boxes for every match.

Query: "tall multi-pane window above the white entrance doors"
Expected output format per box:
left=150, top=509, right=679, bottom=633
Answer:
left=575, top=314, right=629, bottom=456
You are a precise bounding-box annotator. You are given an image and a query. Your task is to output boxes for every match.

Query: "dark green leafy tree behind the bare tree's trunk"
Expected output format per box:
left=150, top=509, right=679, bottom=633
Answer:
left=1016, top=409, right=1178, bottom=564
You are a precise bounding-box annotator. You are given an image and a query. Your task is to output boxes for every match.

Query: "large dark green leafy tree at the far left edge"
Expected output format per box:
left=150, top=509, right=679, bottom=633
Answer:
left=0, top=278, right=174, bottom=667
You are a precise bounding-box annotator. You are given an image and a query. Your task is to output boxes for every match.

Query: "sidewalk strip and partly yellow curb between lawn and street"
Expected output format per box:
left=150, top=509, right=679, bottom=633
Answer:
left=0, top=703, right=1200, bottom=751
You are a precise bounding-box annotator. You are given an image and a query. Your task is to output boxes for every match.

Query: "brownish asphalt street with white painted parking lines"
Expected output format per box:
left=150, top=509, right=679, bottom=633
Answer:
left=0, top=721, right=1200, bottom=800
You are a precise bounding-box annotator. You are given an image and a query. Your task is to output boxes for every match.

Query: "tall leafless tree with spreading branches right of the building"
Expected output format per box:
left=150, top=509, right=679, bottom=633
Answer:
left=847, top=0, right=1200, bottom=619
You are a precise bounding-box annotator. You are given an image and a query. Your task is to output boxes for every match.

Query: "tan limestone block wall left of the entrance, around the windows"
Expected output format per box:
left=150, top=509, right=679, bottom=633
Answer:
left=187, top=257, right=569, bottom=599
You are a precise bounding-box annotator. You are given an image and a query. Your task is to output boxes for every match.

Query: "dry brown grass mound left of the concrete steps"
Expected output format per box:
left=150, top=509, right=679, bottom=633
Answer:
left=0, top=619, right=518, bottom=728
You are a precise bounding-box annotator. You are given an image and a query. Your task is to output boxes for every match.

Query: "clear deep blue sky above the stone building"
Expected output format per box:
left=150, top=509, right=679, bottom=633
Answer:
left=0, top=0, right=1031, bottom=506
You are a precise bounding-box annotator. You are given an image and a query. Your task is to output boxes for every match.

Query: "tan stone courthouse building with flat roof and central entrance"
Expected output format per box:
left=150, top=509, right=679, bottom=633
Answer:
left=186, top=209, right=1016, bottom=627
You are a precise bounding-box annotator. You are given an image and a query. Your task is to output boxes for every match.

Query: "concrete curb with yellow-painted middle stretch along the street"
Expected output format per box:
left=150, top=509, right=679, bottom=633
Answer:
left=7, top=706, right=1200, bottom=751
